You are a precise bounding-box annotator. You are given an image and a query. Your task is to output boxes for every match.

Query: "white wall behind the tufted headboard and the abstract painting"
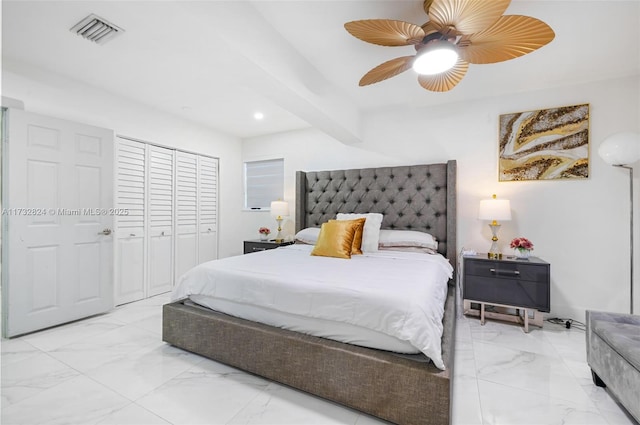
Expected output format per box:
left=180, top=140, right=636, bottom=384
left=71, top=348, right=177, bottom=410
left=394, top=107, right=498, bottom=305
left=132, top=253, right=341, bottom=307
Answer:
left=242, top=76, right=640, bottom=321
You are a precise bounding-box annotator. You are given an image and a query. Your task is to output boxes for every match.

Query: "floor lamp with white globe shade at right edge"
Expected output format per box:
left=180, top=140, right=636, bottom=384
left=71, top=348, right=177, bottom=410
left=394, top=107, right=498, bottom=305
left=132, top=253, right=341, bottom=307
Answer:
left=598, top=133, right=640, bottom=314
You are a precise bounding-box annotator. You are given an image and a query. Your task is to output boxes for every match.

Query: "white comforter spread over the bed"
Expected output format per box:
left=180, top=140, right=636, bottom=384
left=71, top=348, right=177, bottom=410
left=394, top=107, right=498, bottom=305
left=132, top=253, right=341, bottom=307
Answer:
left=172, top=245, right=453, bottom=370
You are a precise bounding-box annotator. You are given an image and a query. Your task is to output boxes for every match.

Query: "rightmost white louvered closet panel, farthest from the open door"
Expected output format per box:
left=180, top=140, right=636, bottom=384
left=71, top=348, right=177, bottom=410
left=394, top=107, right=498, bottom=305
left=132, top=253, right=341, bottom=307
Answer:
left=198, top=156, right=218, bottom=263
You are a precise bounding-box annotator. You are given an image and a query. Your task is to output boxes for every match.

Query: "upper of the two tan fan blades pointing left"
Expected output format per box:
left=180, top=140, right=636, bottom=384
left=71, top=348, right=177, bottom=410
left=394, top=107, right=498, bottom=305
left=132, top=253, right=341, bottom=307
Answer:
left=344, top=19, right=424, bottom=46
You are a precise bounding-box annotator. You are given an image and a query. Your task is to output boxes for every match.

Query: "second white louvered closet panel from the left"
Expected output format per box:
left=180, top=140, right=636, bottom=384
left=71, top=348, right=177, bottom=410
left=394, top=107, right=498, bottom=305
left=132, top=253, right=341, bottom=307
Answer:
left=147, top=145, right=175, bottom=297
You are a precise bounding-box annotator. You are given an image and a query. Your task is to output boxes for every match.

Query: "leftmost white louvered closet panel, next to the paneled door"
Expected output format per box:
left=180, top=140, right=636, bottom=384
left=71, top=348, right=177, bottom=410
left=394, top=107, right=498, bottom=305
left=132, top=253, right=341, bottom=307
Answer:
left=115, top=138, right=146, bottom=305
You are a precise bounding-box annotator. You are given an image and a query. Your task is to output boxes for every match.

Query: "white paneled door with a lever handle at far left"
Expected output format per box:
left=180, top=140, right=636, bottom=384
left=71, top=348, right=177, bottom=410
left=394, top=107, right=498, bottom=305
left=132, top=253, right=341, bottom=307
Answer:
left=2, top=109, right=113, bottom=337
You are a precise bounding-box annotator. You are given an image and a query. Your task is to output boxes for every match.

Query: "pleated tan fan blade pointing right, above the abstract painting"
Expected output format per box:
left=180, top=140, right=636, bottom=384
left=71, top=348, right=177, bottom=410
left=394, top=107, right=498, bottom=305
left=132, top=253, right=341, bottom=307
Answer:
left=458, top=15, right=555, bottom=64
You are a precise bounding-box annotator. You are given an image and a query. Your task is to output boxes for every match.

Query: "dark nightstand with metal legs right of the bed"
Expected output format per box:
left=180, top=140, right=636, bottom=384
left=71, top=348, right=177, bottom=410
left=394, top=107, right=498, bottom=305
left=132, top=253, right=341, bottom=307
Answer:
left=462, top=254, right=551, bottom=332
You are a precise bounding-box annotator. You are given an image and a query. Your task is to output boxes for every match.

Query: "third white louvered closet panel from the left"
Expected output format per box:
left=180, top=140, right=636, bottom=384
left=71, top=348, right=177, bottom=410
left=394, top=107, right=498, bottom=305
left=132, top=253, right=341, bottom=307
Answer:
left=175, top=151, right=198, bottom=282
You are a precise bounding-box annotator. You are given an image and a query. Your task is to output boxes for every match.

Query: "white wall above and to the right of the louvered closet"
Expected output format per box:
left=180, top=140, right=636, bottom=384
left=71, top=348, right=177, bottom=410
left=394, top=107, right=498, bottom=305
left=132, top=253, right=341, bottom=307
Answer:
left=2, top=63, right=242, bottom=257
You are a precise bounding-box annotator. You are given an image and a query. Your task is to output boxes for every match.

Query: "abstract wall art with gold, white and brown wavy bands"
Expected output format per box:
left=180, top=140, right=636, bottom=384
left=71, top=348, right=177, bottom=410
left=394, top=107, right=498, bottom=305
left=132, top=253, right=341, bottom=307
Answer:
left=498, top=104, right=589, bottom=181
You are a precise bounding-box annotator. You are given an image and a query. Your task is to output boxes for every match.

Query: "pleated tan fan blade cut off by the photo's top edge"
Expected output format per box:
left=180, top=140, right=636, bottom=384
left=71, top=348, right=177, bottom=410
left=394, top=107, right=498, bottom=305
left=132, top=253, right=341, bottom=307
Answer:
left=429, top=0, right=511, bottom=34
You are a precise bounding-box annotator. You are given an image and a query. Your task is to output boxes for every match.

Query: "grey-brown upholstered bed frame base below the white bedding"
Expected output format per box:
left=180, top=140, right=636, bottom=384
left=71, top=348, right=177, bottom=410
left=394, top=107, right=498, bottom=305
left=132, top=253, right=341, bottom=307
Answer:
left=162, top=286, right=456, bottom=425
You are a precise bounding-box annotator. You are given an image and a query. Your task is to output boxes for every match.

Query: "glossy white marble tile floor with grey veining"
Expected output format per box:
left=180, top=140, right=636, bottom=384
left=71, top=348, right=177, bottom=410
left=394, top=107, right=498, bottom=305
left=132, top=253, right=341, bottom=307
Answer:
left=0, top=295, right=634, bottom=425
